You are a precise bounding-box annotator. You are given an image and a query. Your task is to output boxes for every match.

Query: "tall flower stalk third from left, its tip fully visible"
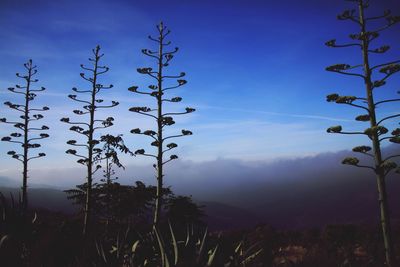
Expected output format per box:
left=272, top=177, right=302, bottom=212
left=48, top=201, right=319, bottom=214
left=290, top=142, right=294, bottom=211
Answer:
left=128, top=22, right=195, bottom=229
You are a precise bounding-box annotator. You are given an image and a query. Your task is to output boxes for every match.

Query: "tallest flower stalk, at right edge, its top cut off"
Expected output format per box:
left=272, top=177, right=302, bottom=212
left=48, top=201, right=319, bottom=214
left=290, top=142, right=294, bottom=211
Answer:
left=326, top=0, right=400, bottom=266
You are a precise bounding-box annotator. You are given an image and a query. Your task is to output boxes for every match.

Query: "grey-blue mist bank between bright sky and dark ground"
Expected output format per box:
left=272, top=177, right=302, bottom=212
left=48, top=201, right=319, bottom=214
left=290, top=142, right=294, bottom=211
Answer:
left=0, top=146, right=400, bottom=227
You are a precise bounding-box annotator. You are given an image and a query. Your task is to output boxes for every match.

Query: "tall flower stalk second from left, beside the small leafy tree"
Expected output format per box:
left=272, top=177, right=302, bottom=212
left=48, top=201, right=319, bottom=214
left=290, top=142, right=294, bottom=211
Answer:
left=61, top=46, right=119, bottom=235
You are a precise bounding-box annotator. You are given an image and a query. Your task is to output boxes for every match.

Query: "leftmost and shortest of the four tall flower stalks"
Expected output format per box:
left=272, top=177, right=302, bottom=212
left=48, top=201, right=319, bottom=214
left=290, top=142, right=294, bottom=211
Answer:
left=0, top=59, right=49, bottom=212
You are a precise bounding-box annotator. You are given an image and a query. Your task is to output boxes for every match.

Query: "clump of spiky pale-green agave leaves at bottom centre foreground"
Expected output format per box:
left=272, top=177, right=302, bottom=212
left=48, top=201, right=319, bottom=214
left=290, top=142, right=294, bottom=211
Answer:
left=96, top=223, right=262, bottom=267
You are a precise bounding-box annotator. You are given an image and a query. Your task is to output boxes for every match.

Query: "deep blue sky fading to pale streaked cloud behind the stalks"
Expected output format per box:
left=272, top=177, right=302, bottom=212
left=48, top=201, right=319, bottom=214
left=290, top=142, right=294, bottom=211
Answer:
left=0, top=0, right=400, bottom=188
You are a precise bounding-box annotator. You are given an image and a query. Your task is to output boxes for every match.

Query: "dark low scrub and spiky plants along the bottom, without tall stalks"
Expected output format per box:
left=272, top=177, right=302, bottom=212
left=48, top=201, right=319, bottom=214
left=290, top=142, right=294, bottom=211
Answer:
left=0, top=193, right=400, bottom=267
